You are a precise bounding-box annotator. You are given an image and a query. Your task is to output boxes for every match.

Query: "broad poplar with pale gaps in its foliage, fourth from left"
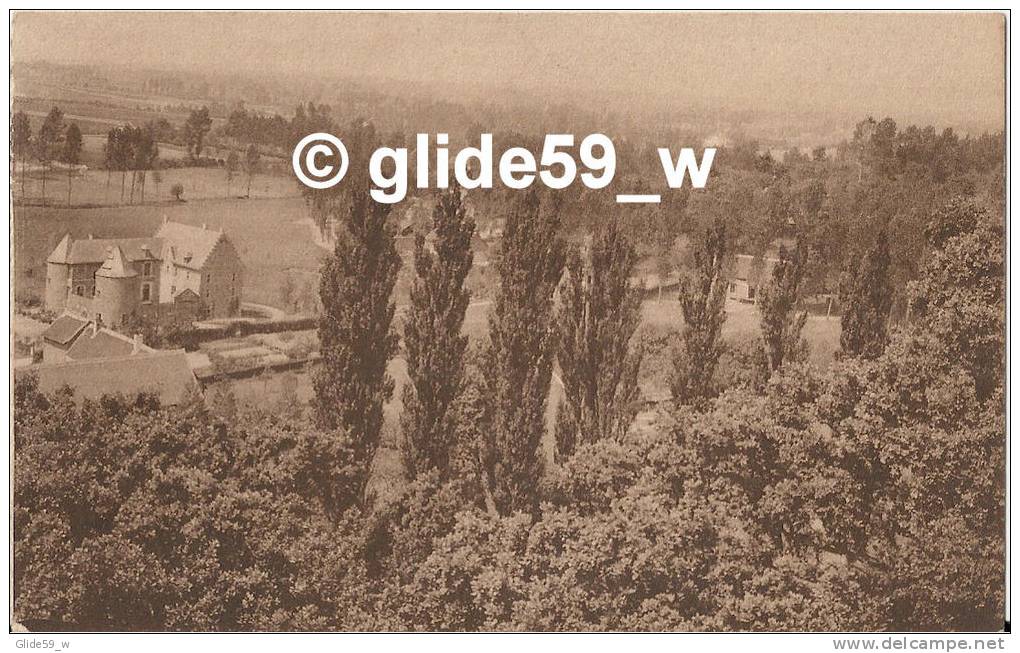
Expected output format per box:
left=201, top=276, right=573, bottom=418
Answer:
left=556, top=219, right=642, bottom=459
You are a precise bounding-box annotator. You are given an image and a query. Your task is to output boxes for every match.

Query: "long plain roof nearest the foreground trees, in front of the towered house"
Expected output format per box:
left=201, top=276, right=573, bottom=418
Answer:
left=22, top=349, right=197, bottom=405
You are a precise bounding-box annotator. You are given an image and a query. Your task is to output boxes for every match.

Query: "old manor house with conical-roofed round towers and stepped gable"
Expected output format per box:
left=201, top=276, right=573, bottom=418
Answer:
left=46, top=220, right=244, bottom=329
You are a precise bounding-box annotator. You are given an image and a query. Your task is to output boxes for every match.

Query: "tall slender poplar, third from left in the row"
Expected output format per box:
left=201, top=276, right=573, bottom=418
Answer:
left=481, top=191, right=565, bottom=514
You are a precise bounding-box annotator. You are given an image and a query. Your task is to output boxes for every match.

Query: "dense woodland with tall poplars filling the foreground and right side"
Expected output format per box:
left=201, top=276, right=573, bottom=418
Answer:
left=13, top=103, right=1005, bottom=631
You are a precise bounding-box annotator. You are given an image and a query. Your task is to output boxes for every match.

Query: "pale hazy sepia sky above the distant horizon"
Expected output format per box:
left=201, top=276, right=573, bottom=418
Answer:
left=12, top=12, right=1005, bottom=126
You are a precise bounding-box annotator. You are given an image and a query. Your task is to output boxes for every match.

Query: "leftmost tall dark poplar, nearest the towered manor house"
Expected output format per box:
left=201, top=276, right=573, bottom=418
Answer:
left=314, top=194, right=400, bottom=508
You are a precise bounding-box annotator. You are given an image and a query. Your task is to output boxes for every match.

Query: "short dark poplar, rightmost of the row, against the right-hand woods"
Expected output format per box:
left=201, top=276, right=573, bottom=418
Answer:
left=839, top=229, right=893, bottom=358
